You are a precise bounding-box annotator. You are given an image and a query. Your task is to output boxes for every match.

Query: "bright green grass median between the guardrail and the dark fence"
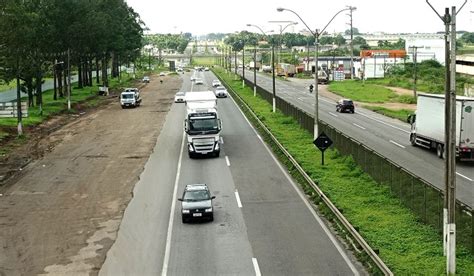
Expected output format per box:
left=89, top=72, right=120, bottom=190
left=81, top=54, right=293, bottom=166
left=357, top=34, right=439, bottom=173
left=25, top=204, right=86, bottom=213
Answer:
left=214, top=68, right=474, bottom=275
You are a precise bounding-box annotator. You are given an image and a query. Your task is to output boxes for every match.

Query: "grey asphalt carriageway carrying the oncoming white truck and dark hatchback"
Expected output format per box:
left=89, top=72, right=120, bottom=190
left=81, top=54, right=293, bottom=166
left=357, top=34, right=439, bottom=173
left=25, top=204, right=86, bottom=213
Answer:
left=99, top=72, right=367, bottom=275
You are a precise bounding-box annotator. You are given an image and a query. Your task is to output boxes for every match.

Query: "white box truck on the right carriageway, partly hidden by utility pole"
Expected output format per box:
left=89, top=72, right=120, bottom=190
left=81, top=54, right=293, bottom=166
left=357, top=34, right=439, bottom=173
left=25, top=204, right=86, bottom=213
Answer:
left=407, top=93, right=474, bottom=161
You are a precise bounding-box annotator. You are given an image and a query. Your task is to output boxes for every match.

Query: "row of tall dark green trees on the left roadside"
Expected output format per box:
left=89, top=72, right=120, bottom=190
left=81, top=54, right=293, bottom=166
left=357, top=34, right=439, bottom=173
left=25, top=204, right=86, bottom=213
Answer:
left=0, top=0, right=144, bottom=111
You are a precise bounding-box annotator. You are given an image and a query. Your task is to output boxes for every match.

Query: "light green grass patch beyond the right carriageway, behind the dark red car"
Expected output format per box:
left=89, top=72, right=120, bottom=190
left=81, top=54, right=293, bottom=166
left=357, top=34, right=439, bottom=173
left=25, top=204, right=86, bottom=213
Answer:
left=328, top=80, right=416, bottom=121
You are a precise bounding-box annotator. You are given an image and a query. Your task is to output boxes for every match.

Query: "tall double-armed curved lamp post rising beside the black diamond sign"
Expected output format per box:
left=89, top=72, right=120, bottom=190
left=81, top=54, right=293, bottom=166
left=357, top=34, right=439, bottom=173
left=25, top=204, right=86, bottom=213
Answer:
left=277, top=7, right=352, bottom=139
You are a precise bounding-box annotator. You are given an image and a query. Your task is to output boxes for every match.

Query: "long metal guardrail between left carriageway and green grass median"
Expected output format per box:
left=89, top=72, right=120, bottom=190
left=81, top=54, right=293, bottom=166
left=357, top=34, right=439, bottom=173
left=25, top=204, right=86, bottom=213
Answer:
left=216, top=70, right=393, bottom=275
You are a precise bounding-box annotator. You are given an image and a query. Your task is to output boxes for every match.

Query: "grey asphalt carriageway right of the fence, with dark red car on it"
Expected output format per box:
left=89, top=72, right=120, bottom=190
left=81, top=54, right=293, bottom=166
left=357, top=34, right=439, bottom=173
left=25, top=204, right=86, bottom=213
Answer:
left=235, top=70, right=474, bottom=208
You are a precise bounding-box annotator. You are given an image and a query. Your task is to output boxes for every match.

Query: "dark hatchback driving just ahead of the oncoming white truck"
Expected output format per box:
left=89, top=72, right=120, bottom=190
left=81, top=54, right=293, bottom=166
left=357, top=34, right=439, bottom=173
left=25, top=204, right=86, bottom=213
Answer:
left=178, top=184, right=216, bottom=223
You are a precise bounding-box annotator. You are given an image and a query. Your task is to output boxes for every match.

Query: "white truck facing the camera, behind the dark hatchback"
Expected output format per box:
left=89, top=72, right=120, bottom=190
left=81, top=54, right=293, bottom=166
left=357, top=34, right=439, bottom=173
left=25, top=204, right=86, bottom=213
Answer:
left=184, top=91, right=222, bottom=158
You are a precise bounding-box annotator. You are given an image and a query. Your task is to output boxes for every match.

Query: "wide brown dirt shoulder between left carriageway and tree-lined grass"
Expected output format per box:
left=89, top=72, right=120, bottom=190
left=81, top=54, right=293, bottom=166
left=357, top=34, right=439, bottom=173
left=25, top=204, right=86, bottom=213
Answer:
left=0, top=76, right=181, bottom=275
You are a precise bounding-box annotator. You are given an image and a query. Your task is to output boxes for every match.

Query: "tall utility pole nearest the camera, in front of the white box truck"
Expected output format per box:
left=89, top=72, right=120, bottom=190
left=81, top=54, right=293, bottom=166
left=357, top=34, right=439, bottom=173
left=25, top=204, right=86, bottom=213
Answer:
left=426, top=0, right=467, bottom=275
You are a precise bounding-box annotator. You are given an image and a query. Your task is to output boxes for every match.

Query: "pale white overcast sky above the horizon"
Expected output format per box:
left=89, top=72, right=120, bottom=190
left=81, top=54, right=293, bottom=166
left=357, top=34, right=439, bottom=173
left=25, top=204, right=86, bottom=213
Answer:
left=126, top=0, right=474, bottom=35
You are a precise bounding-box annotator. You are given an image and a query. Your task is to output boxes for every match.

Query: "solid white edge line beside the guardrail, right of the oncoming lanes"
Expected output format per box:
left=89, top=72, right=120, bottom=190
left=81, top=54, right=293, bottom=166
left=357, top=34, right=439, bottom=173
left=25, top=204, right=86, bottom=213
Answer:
left=232, top=91, right=360, bottom=276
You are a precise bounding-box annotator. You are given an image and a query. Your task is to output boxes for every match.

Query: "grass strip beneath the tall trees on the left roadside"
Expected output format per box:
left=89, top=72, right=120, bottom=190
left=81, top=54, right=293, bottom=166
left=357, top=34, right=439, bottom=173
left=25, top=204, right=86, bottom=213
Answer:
left=0, top=73, right=150, bottom=142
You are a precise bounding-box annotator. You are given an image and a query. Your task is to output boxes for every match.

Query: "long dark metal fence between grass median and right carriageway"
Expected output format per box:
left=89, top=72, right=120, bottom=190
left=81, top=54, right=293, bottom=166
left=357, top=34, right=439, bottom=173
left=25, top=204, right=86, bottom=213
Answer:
left=246, top=76, right=474, bottom=254
